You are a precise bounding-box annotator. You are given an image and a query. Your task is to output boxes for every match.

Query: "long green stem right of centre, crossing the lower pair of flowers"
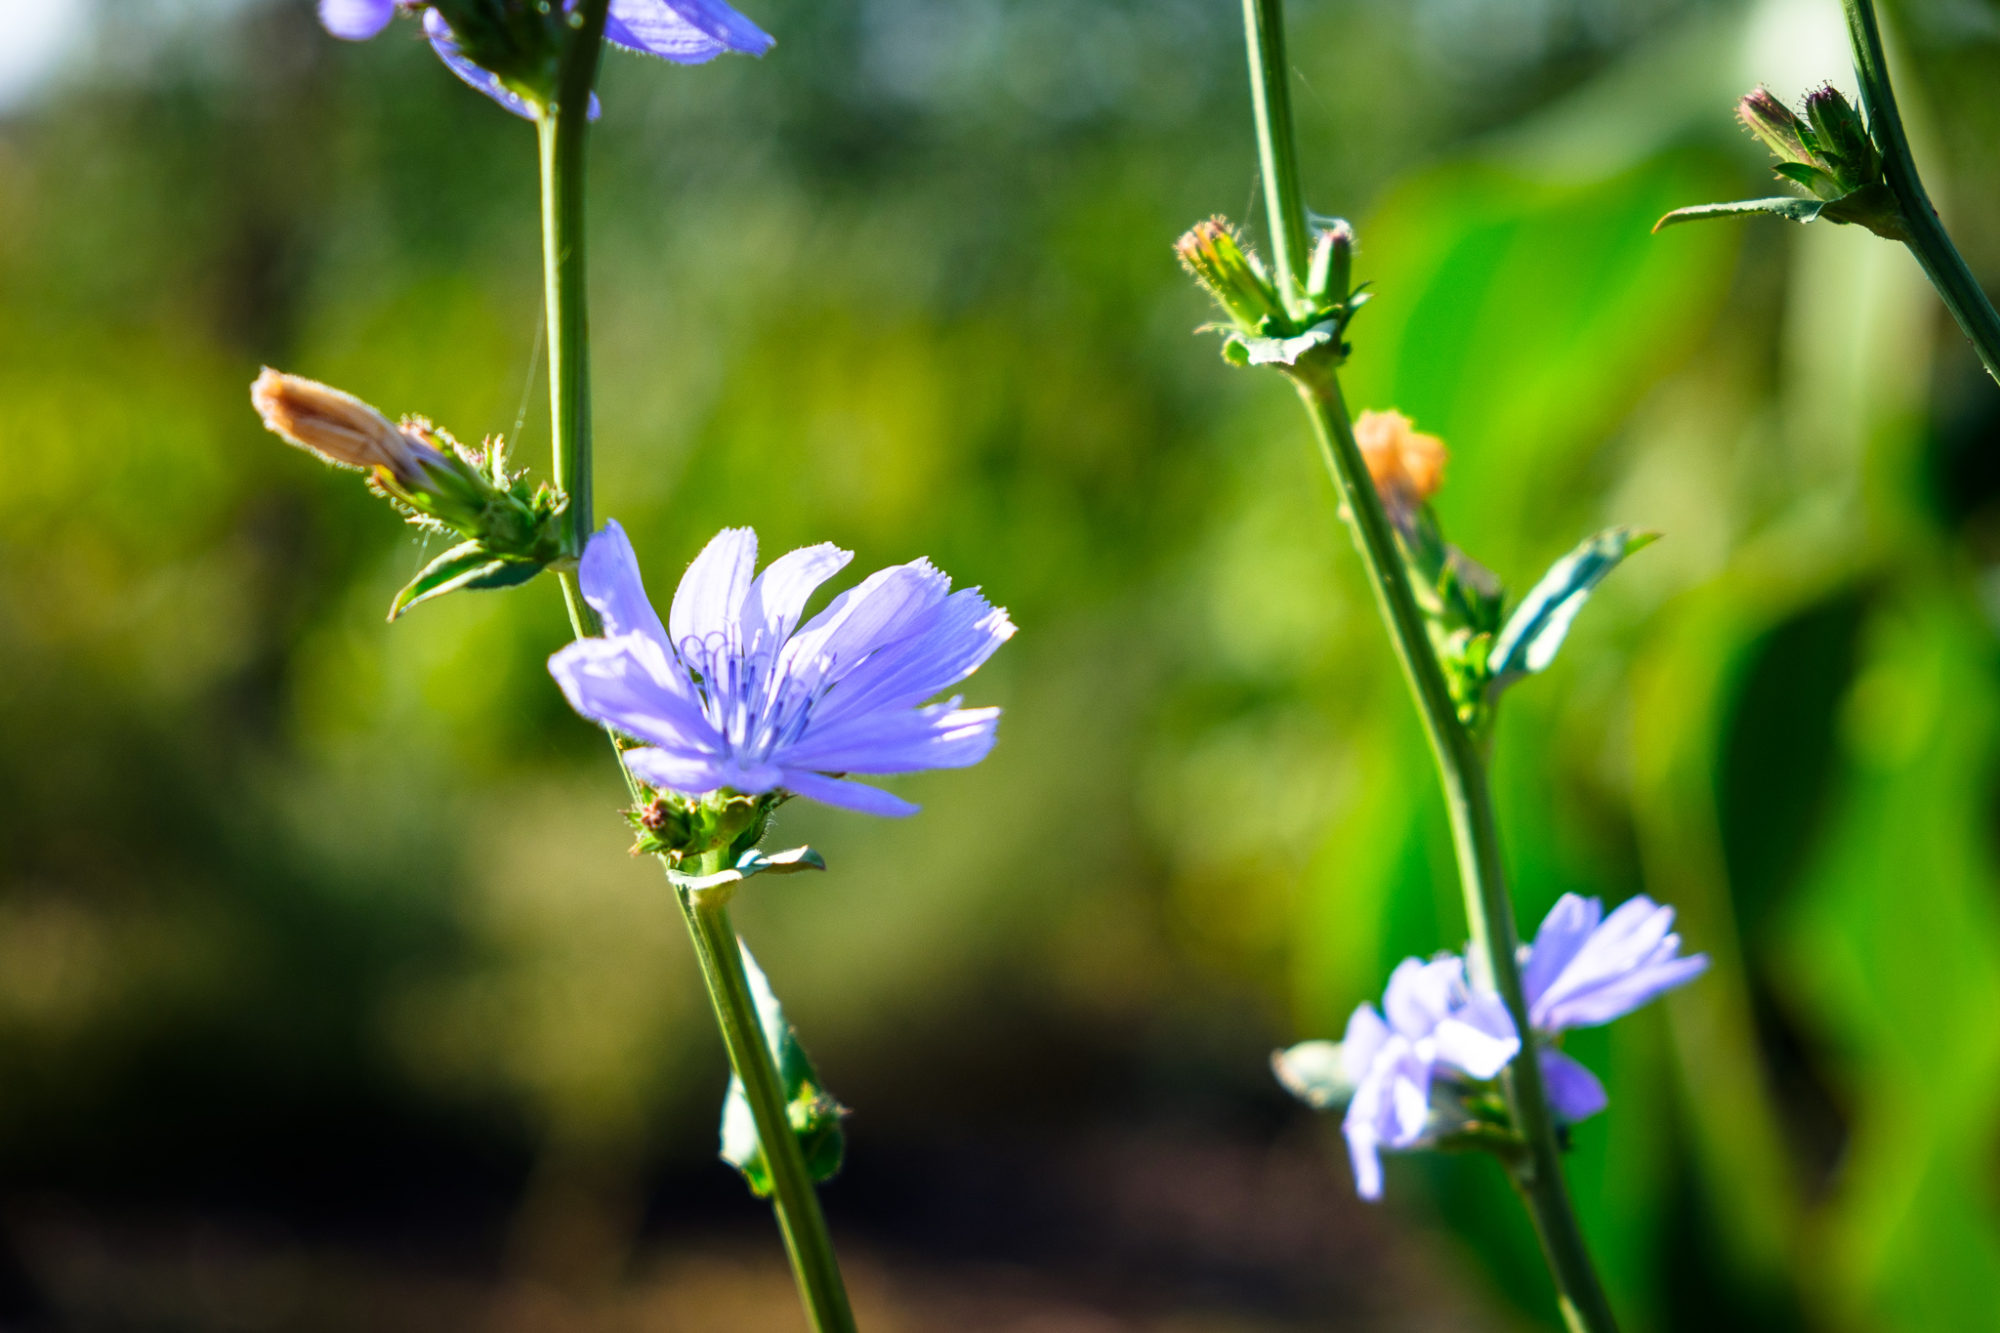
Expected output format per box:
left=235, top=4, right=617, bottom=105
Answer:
left=1244, top=0, right=1618, bottom=1333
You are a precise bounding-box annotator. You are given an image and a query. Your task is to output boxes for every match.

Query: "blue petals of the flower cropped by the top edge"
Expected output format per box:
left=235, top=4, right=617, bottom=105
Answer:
left=320, top=0, right=774, bottom=120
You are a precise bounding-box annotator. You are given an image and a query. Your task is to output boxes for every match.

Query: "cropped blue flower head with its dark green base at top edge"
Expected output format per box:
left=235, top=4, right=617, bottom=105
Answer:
left=320, top=0, right=772, bottom=120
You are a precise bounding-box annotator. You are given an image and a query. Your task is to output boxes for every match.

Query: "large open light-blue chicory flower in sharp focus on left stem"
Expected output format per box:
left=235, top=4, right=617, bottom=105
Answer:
left=548, top=522, right=1014, bottom=815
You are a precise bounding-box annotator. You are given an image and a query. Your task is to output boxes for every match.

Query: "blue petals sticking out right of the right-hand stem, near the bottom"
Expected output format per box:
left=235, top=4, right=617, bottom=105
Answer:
left=1520, top=893, right=1708, bottom=1123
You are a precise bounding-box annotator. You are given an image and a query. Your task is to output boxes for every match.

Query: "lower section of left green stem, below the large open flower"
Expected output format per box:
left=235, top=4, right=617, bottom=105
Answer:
left=676, top=872, right=854, bottom=1333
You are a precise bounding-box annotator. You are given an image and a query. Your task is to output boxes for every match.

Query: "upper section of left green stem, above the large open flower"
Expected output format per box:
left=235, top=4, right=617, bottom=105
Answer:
left=536, top=0, right=610, bottom=556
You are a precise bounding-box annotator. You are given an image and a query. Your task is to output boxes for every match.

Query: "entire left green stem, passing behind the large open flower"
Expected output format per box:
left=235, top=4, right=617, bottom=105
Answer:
left=538, top=0, right=854, bottom=1333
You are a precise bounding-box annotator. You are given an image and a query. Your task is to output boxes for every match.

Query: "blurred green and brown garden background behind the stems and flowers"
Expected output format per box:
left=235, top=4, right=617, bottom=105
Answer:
left=0, top=0, right=2000, bottom=1333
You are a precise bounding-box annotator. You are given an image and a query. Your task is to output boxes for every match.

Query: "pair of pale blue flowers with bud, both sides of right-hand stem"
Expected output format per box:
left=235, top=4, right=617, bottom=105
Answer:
left=1272, top=893, right=1708, bottom=1199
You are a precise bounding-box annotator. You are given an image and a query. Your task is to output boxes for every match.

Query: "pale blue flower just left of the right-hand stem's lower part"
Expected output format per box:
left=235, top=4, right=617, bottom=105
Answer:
left=1340, top=955, right=1520, bottom=1199
